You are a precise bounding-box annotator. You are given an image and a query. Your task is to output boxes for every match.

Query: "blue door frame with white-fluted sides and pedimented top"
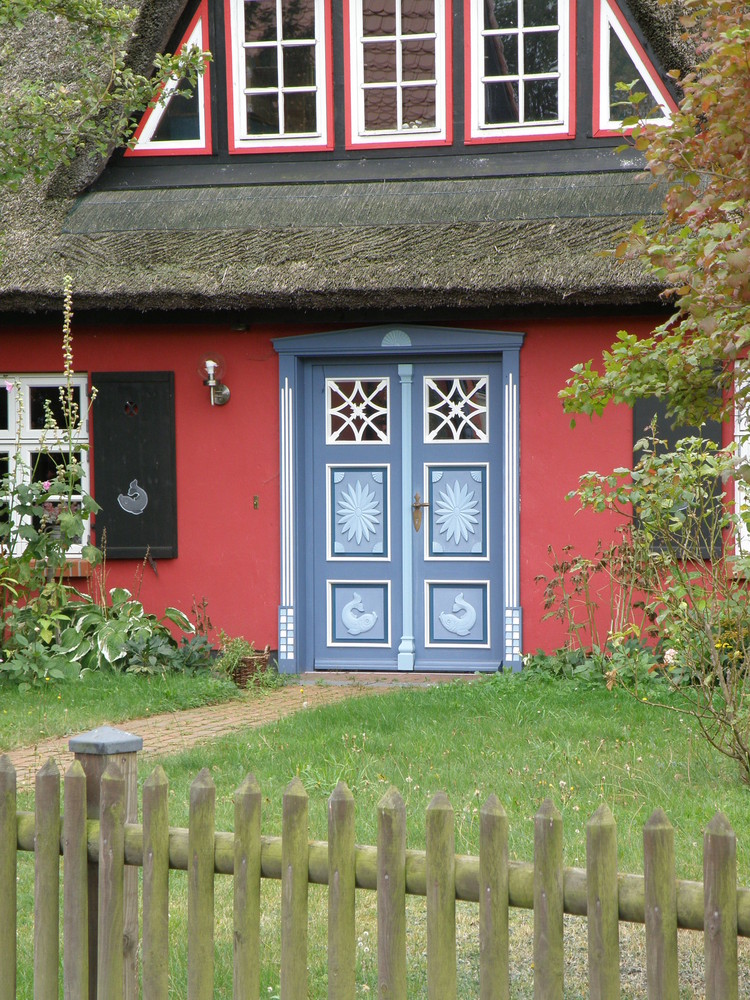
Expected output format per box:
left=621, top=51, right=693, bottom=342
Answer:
left=273, top=324, right=524, bottom=674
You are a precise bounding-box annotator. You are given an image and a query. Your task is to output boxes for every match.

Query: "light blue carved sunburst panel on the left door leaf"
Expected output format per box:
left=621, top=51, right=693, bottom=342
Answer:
left=328, top=465, right=389, bottom=559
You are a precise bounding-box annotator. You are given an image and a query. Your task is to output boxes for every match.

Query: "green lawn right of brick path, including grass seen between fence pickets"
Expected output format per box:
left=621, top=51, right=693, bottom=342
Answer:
left=7, top=675, right=750, bottom=1000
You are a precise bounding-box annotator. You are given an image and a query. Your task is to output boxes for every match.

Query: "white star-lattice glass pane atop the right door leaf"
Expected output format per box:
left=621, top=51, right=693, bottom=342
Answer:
left=424, top=375, right=489, bottom=442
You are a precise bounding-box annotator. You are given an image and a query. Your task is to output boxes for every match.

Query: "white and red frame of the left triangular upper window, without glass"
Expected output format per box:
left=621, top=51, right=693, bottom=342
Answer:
left=125, top=0, right=212, bottom=156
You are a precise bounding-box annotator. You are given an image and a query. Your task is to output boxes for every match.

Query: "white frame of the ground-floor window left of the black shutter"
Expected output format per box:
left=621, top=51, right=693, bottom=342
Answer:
left=0, top=373, right=91, bottom=559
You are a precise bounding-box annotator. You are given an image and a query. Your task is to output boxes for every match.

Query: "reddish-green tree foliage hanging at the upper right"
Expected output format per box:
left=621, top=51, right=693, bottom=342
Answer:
left=561, top=0, right=750, bottom=424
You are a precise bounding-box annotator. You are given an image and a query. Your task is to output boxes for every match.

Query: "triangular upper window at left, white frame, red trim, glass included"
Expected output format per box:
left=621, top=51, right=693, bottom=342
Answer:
left=124, top=0, right=213, bottom=156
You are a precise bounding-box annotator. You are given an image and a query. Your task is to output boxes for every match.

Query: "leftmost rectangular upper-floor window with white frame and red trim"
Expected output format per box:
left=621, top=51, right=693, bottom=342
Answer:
left=226, top=0, right=333, bottom=153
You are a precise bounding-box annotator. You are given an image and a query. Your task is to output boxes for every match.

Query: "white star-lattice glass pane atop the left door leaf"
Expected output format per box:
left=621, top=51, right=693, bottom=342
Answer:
left=326, top=378, right=390, bottom=444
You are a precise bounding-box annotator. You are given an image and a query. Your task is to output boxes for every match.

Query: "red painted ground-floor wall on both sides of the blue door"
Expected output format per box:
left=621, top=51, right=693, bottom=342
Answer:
left=0, top=314, right=664, bottom=651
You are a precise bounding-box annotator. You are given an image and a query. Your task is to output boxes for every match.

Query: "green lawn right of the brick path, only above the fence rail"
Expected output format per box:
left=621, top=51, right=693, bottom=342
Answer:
left=147, top=675, right=750, bottom=884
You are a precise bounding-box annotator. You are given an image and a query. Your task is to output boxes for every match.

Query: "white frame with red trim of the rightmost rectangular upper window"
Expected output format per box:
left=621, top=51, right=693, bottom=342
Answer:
left=465, top=0, right=576, bottom=143
